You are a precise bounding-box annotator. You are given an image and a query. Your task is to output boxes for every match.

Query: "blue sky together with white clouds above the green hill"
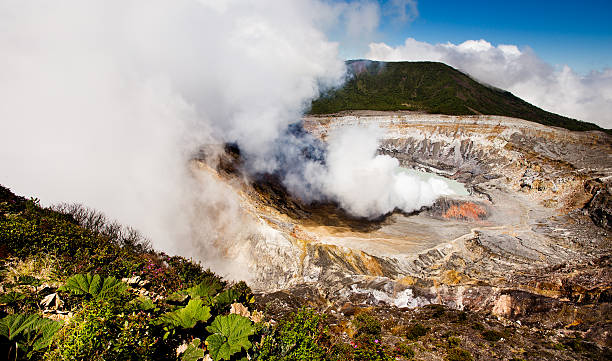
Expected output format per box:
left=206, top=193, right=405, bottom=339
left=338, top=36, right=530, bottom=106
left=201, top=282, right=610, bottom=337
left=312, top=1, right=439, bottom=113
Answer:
left=327, top=0, right=612, bottom=129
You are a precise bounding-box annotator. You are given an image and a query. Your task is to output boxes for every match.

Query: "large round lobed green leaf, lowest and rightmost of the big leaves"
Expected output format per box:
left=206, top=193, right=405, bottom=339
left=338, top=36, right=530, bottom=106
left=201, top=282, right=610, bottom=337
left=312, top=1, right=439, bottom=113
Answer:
left=206, top=314, right=255, bottom=361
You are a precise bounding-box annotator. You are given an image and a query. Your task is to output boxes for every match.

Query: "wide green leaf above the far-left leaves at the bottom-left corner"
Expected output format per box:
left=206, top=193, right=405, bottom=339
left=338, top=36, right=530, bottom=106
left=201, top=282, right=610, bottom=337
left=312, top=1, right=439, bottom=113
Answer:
left=59, top=273, right=127, bottom=298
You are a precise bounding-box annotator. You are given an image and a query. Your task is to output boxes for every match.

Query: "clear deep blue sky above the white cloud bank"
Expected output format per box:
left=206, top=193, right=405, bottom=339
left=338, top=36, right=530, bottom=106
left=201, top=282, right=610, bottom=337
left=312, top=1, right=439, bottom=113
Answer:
left=341, top=0, right=612, bottom=74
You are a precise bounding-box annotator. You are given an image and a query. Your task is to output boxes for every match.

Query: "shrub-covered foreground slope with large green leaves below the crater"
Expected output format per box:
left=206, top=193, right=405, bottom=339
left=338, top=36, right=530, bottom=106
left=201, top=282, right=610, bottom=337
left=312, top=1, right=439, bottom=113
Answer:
left=0, top=185, right=610, bottom=361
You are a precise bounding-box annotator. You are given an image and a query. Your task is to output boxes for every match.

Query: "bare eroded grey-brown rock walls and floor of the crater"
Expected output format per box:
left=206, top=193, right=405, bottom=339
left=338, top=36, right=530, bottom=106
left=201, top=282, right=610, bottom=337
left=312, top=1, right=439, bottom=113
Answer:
left=194, top=112, right=612, bottom=344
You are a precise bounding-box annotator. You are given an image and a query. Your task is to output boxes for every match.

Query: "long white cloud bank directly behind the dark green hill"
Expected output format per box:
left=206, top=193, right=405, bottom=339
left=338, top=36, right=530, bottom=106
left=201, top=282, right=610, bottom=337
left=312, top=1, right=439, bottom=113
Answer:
left=366, top=38, right=612, bottom=128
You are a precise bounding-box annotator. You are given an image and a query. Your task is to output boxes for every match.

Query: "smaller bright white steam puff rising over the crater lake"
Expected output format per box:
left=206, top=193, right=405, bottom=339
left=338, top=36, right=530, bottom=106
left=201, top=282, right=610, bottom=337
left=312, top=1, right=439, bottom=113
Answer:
left=309, top=127, right=454, bottom=218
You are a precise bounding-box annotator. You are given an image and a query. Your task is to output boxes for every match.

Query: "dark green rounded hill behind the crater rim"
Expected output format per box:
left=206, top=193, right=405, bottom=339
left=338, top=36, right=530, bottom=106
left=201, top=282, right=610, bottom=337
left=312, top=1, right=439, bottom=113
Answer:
left=310, top=60, right=603, bottom=130
